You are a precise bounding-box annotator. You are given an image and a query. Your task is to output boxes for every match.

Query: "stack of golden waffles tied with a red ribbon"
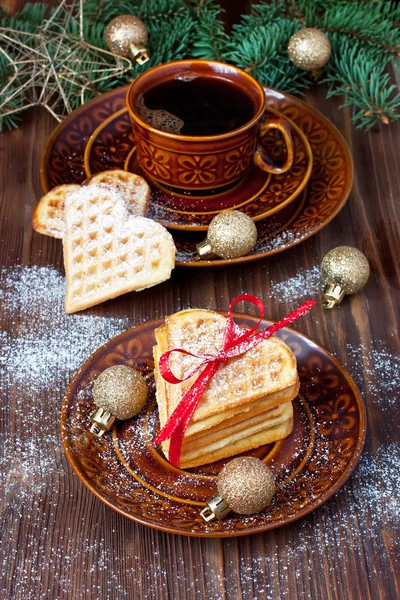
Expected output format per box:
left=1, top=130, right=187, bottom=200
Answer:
left=153, top=309, right=299, bottom=468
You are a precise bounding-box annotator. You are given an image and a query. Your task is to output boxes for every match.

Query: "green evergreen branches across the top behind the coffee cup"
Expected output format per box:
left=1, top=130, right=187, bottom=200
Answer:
left=0, top=0, right=400, bottom=129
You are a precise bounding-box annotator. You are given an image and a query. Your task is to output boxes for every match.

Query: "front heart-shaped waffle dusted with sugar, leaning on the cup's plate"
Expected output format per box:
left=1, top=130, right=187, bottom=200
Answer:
left=63, top=185, right=175, bottom=313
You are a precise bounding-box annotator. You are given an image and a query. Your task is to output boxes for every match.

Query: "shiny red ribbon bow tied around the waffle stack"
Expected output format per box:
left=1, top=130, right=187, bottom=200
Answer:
left=153, top=294, right=316, bottom=467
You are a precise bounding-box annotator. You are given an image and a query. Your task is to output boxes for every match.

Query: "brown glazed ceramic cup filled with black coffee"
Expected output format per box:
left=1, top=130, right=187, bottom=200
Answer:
left=127, top=60, right=293, bottom=195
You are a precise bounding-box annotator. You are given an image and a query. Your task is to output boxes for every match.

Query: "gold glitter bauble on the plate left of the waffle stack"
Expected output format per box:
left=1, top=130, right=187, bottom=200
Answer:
left=90, top=365, right=147, bottom=437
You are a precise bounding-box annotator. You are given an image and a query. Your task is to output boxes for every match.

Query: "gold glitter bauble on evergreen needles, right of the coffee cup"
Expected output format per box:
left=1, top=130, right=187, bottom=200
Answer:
left=288, top=27, right=331, bottom=72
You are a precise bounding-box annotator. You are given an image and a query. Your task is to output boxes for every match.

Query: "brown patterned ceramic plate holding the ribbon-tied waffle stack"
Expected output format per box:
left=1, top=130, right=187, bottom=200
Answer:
left=61, top=314, right=366, bottom=537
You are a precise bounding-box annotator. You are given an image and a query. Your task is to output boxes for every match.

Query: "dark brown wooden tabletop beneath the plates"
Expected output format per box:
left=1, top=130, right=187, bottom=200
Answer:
left=0, top=0, right=400, bottom=600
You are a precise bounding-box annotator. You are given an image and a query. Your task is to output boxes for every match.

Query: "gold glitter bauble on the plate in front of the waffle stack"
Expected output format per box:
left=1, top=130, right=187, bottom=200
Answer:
left=200, top=456, right=275, bottom=522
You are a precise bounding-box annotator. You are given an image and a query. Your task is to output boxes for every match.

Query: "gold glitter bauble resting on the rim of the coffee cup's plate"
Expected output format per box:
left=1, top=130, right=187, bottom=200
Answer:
left=197, top=210, right=257, bottom=260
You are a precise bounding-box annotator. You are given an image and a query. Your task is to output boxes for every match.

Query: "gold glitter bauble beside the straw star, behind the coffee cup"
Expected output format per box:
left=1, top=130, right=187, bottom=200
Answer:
left=106, top=15, right=149, bottom=65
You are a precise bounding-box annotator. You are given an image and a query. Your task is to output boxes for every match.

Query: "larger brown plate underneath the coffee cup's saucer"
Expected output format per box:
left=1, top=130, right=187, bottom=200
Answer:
left=41, top=88, right=353, bottom=267
